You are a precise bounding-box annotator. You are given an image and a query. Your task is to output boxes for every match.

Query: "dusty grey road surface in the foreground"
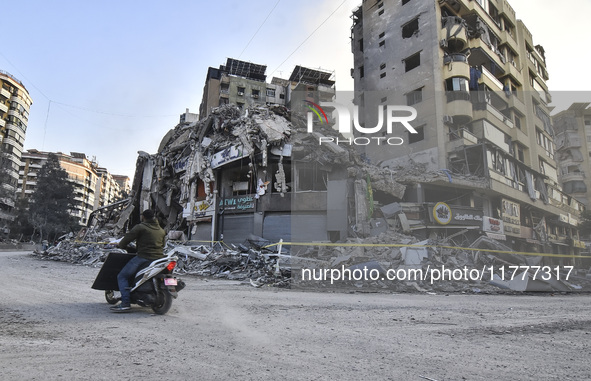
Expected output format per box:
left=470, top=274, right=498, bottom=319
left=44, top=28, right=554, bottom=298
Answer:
left=0, top=249, right=591, bottom=381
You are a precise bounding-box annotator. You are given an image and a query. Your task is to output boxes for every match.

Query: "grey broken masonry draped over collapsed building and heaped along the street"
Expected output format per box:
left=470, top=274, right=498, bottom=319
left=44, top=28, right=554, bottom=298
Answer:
left=38, top=105, right=591, bottom=293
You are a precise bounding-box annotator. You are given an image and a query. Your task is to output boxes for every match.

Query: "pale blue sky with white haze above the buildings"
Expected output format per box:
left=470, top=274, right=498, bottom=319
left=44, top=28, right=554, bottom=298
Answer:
left=0, top=0, right=591, bottom=177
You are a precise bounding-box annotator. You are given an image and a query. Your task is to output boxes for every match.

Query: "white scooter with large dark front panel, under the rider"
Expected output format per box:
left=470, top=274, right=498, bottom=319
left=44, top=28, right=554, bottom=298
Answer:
left=92, top=251, right=185, bottom=315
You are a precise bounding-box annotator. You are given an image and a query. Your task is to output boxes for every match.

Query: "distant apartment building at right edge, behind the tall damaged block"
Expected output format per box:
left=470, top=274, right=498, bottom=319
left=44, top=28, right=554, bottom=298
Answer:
left=552, top=103, right=591, bottom=210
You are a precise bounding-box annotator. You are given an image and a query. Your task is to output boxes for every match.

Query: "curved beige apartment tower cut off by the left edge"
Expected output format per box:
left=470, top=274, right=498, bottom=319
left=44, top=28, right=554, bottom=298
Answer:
left=0, top=70, right=33, bottom=228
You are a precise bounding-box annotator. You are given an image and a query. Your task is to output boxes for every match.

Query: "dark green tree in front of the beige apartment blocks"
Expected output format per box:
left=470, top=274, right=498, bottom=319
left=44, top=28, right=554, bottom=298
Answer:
left=29, top=153, right=77, bottom=240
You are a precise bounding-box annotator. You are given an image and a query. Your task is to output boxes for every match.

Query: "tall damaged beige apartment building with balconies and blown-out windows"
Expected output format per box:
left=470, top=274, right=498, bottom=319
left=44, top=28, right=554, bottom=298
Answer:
left=351, top=0, right=582, bottom=253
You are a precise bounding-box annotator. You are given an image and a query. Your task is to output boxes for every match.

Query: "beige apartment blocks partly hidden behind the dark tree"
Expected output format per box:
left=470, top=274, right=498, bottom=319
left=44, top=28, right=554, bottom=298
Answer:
left=17, top=149, right=123, bottom=225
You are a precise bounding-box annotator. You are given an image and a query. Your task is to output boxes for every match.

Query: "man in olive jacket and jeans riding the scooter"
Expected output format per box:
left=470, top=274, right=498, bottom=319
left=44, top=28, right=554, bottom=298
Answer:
left=111, top=209, right=166, bottom=312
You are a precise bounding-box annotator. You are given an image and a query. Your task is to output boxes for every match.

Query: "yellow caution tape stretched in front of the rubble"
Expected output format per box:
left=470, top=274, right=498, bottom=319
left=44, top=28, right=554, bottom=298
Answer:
left=263, top=242, right=591, bottom=258
